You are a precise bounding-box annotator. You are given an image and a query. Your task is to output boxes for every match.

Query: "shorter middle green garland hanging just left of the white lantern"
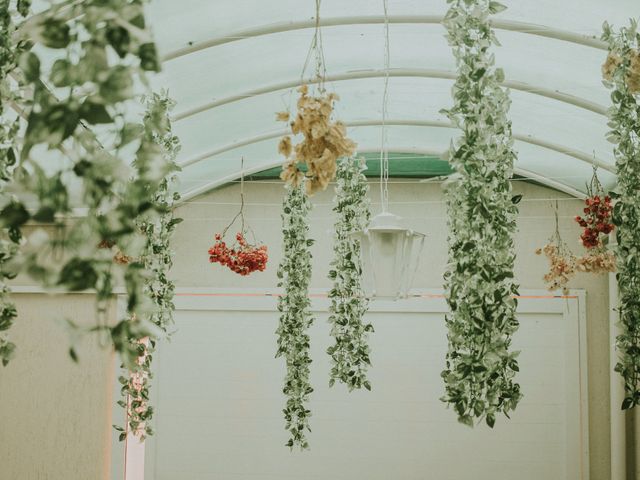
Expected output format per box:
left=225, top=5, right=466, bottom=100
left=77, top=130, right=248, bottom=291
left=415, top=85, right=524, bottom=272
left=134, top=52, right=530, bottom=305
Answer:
left=327, top=157, right=373, bottom=391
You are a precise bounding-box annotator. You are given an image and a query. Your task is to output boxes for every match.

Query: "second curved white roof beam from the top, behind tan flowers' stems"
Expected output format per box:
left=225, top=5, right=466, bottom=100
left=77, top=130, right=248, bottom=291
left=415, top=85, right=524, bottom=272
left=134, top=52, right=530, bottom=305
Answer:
left=172, top=68, right=607, bottom=122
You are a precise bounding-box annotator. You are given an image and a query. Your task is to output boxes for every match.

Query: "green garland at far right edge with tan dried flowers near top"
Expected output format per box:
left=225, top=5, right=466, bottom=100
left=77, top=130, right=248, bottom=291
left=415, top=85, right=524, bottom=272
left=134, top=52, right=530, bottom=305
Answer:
left=603, top=20, right=640, bottom=410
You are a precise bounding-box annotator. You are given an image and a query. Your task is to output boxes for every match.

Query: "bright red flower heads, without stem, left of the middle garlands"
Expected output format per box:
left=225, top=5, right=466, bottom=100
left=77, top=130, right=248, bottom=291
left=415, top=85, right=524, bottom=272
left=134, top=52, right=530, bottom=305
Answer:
left=209, top=233, right=269, bottom=276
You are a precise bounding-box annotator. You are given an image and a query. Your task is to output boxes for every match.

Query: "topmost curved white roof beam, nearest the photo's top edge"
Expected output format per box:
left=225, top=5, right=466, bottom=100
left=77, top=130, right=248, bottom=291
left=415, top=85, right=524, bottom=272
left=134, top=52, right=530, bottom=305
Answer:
left=162, top=15, right=607, bottom=62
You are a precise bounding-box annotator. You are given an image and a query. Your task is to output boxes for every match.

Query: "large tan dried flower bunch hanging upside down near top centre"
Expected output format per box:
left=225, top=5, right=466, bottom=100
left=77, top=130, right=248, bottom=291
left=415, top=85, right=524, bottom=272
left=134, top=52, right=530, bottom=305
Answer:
left=276, top=85, right=356, bottom=195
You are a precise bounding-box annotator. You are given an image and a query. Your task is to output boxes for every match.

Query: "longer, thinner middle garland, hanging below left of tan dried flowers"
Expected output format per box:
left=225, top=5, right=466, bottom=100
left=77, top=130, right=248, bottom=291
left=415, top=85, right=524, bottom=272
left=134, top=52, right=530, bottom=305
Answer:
left=276, top=181, right=313, bottom=449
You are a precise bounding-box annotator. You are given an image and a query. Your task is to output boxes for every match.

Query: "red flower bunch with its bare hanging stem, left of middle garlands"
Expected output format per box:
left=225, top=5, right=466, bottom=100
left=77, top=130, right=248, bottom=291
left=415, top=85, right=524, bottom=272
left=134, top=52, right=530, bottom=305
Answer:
left=209, top=169, right=269, bottom=276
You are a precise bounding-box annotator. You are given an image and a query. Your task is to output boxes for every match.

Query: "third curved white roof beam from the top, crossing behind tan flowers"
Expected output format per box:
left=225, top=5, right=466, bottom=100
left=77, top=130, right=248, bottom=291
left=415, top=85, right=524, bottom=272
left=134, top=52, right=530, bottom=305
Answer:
left=179, top=119, right=616, bottom=174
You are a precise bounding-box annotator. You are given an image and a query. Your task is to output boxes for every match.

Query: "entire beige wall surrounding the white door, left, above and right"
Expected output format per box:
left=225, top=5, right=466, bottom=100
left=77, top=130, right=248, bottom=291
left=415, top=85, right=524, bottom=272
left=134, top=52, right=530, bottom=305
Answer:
left=0, top=181, right=610, bottom=480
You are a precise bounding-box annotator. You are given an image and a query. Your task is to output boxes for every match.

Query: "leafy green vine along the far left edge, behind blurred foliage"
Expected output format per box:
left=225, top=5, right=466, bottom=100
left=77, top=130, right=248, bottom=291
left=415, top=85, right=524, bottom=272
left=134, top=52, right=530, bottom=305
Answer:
left=0, top=0, right=30, bottom=366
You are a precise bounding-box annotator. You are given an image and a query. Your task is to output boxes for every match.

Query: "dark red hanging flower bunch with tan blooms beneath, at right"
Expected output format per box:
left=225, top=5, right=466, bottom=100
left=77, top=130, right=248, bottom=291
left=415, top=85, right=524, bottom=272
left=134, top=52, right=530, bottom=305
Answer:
left=576, top=170, right=616, bottom=274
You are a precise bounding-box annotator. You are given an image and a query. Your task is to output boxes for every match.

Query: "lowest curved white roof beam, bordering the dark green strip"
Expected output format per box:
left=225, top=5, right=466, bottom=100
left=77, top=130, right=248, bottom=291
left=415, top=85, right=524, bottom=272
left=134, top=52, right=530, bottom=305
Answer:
left=177, top=148, right=586, bottom=205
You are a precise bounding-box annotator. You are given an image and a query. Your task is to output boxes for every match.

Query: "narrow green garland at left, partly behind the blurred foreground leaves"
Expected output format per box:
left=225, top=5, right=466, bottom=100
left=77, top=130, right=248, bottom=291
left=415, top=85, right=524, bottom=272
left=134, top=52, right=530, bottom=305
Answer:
left=114, top=92, right=182, bottom=440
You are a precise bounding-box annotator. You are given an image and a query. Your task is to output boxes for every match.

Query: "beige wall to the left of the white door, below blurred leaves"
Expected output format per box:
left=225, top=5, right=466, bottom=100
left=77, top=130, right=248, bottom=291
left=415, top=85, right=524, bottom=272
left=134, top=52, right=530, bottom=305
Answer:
left=0, top=294, right=113, bottom=480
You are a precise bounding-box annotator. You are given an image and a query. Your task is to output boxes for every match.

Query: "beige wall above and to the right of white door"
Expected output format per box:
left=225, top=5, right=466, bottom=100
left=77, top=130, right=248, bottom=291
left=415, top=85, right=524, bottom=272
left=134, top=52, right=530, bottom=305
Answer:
left=173, top=180, right=610, bottom=480
